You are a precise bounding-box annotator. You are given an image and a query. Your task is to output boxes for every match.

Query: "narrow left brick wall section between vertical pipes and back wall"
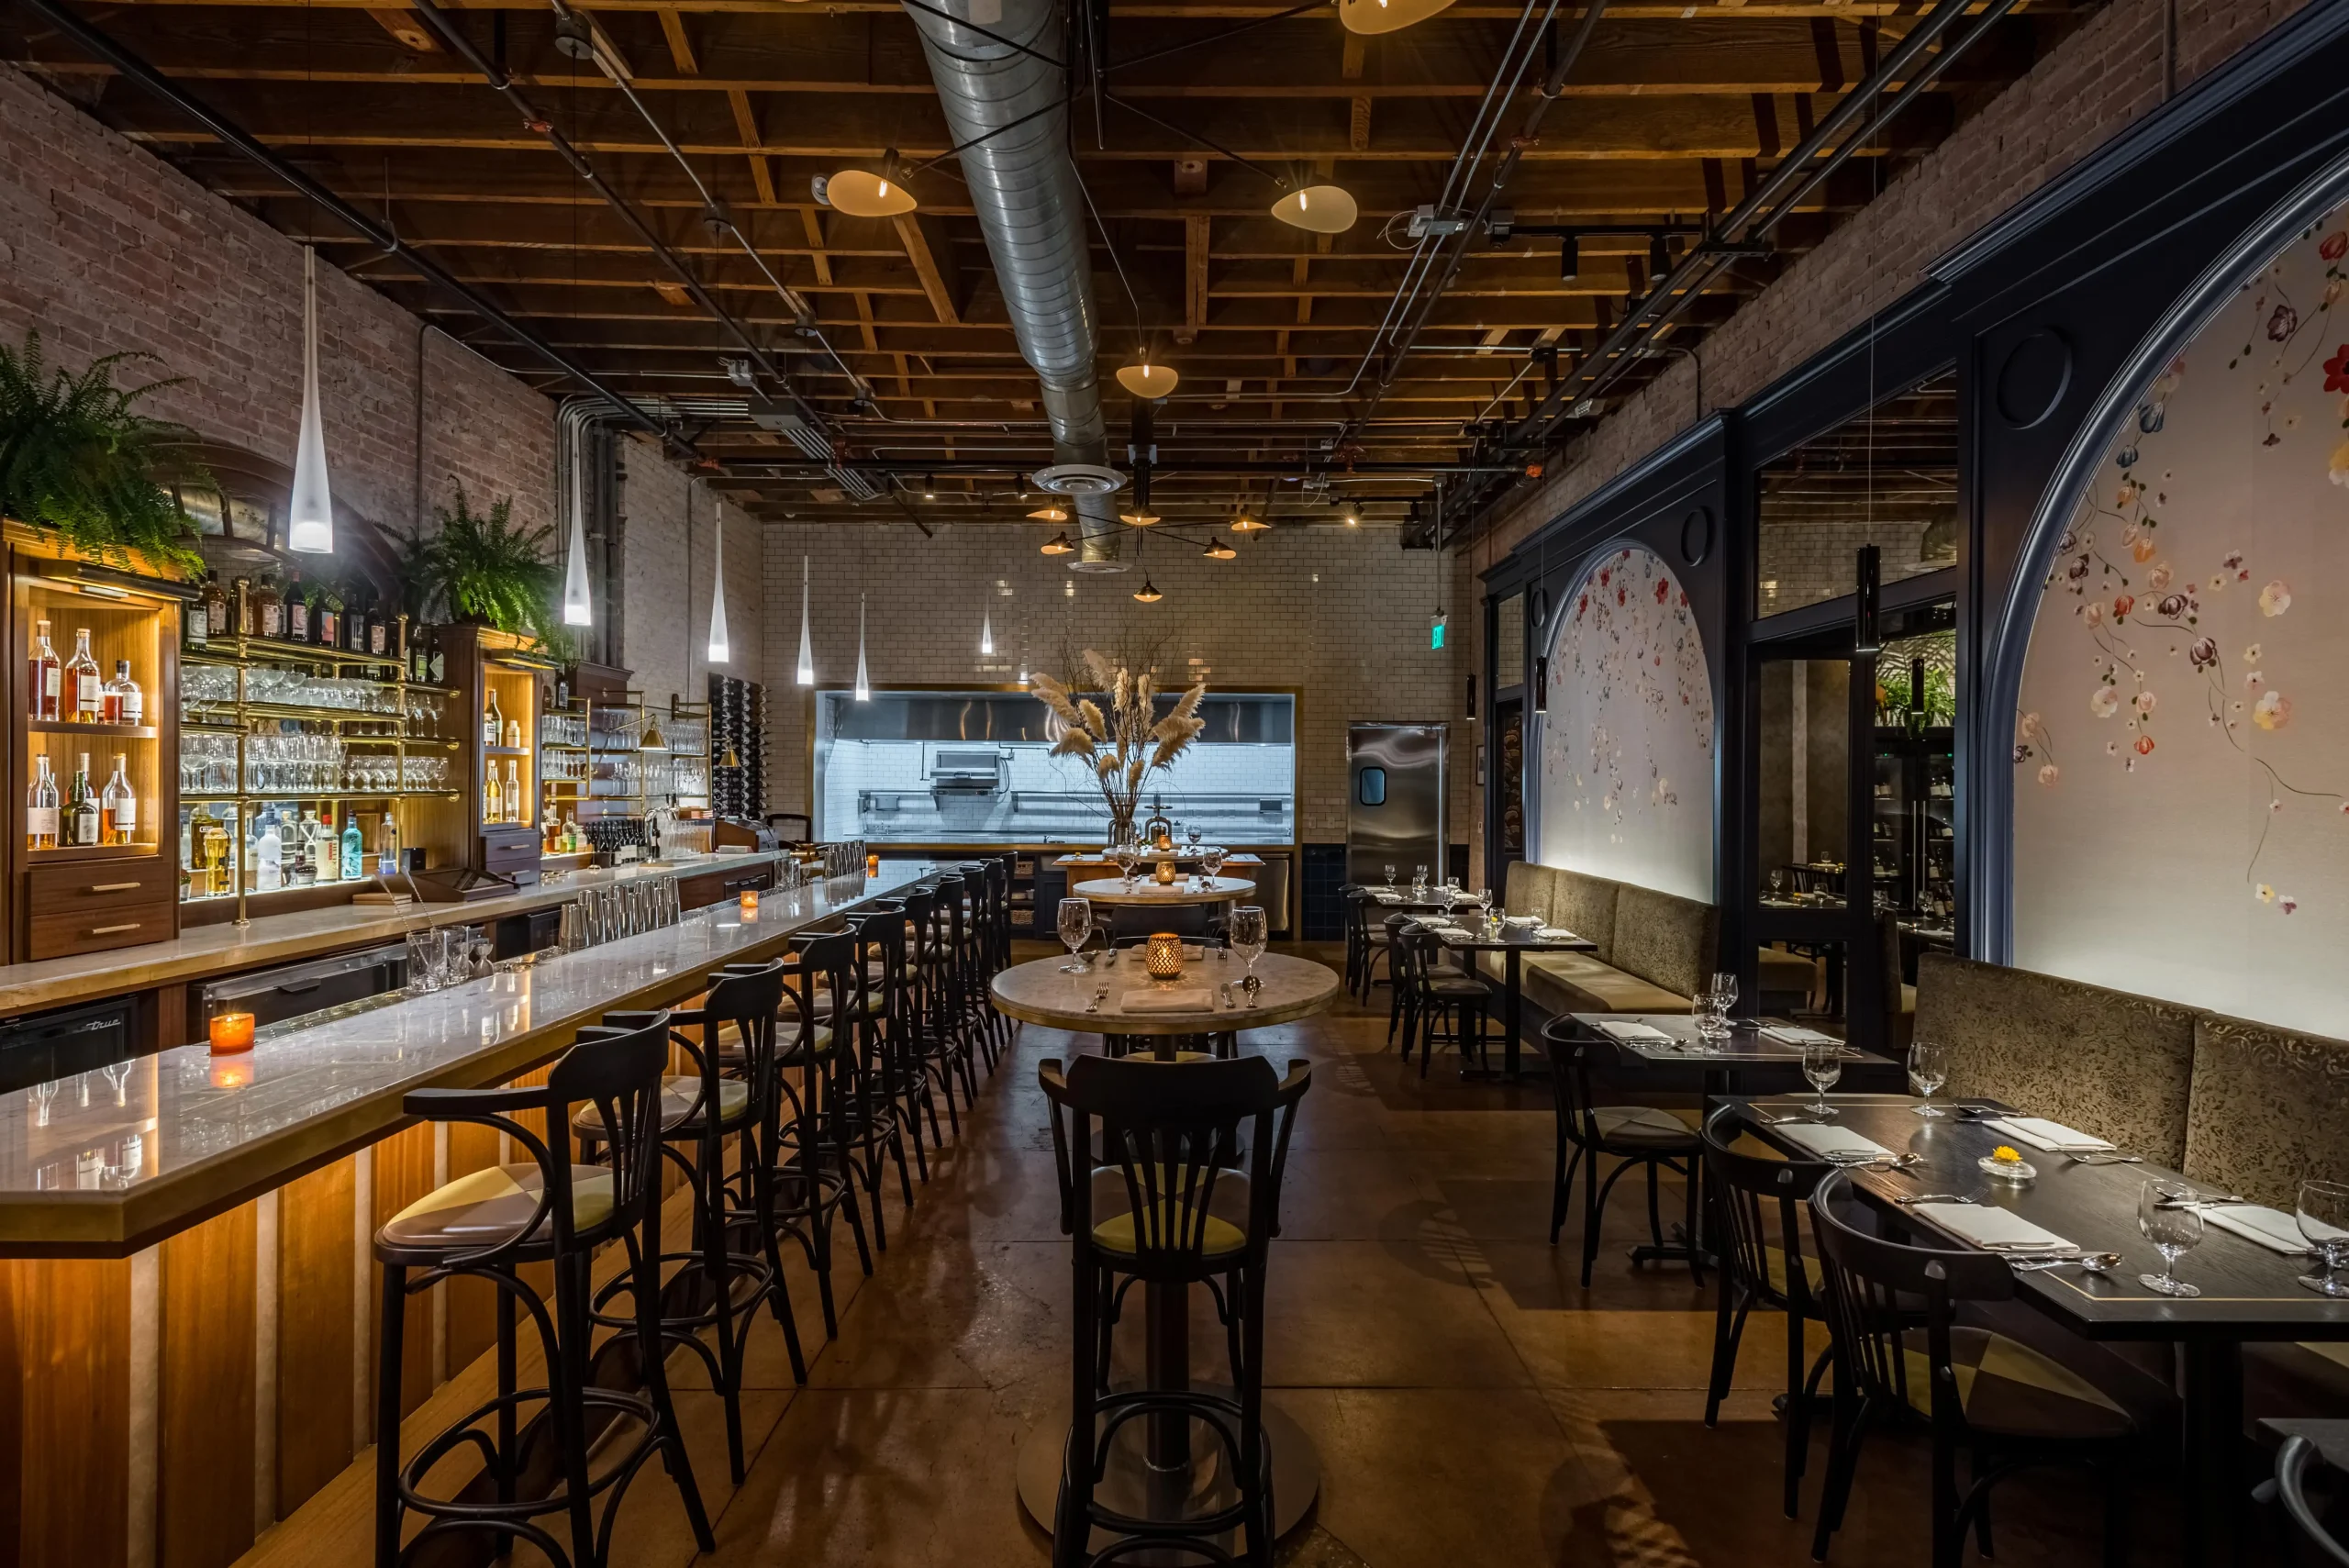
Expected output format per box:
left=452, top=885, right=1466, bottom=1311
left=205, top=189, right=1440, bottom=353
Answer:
left=620, top=439, right=765, bottom=702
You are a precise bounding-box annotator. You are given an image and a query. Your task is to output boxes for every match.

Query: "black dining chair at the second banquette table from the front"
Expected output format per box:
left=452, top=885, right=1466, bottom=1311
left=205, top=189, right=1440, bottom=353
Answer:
left=1541, top=1018, right=1703, bottom=1286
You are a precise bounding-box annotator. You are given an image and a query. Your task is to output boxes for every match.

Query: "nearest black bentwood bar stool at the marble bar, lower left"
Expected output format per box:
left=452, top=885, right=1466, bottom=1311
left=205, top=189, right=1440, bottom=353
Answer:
left=376, top=1017, right=717, bottom=1568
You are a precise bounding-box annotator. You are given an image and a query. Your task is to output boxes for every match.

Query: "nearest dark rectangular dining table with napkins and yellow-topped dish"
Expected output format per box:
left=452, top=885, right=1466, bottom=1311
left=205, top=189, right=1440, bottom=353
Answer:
left=1731, top=1094, right=2349, bottom=1568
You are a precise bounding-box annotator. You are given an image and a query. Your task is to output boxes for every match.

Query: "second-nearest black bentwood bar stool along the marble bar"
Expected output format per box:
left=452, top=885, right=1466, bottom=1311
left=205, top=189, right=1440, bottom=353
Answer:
left=571, top=962, right=808, bottom=1485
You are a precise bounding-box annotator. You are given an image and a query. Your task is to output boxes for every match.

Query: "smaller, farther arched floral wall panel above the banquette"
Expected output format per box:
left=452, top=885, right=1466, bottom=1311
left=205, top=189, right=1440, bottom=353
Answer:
left=1536, top=545, right=1712, bottom=904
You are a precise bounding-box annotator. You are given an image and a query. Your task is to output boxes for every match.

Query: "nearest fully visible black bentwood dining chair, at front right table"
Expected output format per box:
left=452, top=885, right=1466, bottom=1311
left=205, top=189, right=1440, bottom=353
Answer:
left=1811, top=1172, right=2154, bottom=1568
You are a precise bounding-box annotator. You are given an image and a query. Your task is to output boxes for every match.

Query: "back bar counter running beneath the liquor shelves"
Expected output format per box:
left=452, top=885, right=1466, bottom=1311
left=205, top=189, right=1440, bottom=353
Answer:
left=0, top=850, right=785, bottom=1018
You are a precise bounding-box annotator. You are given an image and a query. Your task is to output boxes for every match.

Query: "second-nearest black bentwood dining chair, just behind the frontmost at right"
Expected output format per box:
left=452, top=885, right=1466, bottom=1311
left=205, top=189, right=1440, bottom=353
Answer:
left=1698, top=1106, right=1834, bottom=1518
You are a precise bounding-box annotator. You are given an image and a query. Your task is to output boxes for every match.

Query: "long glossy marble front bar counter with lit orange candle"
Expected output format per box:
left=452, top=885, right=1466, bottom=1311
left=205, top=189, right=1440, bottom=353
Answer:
left=0, top=859, right=937, bottom=1258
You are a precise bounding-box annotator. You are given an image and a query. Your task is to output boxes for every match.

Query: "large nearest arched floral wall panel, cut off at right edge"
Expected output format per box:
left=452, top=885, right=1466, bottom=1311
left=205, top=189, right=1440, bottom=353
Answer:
left=2013, top=192, right=2349, bottom=1035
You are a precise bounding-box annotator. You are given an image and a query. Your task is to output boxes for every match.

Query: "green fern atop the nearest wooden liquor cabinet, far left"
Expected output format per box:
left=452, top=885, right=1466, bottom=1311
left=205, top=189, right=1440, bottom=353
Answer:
left=0, top=331, right=209, bottom=575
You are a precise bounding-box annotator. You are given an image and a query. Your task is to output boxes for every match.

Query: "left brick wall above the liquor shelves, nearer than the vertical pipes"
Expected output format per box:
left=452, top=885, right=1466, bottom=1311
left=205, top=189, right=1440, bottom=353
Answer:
left=0, top=66, right=554, bottom=544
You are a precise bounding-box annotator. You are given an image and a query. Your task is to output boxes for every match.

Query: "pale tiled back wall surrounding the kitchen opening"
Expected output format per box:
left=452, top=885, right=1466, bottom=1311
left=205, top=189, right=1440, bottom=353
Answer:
left=756, top=524, right=1475, bottom=842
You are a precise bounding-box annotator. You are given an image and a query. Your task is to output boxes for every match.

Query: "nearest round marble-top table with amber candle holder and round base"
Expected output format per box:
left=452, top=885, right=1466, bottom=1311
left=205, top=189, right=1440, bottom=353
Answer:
left=994, top=949, right=1339, bottom=1561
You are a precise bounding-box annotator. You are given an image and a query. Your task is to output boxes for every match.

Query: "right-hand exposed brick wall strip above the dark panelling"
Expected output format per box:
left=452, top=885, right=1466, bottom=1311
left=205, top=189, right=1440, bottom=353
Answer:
left=1475, top=0, right=2307, bottom=568
